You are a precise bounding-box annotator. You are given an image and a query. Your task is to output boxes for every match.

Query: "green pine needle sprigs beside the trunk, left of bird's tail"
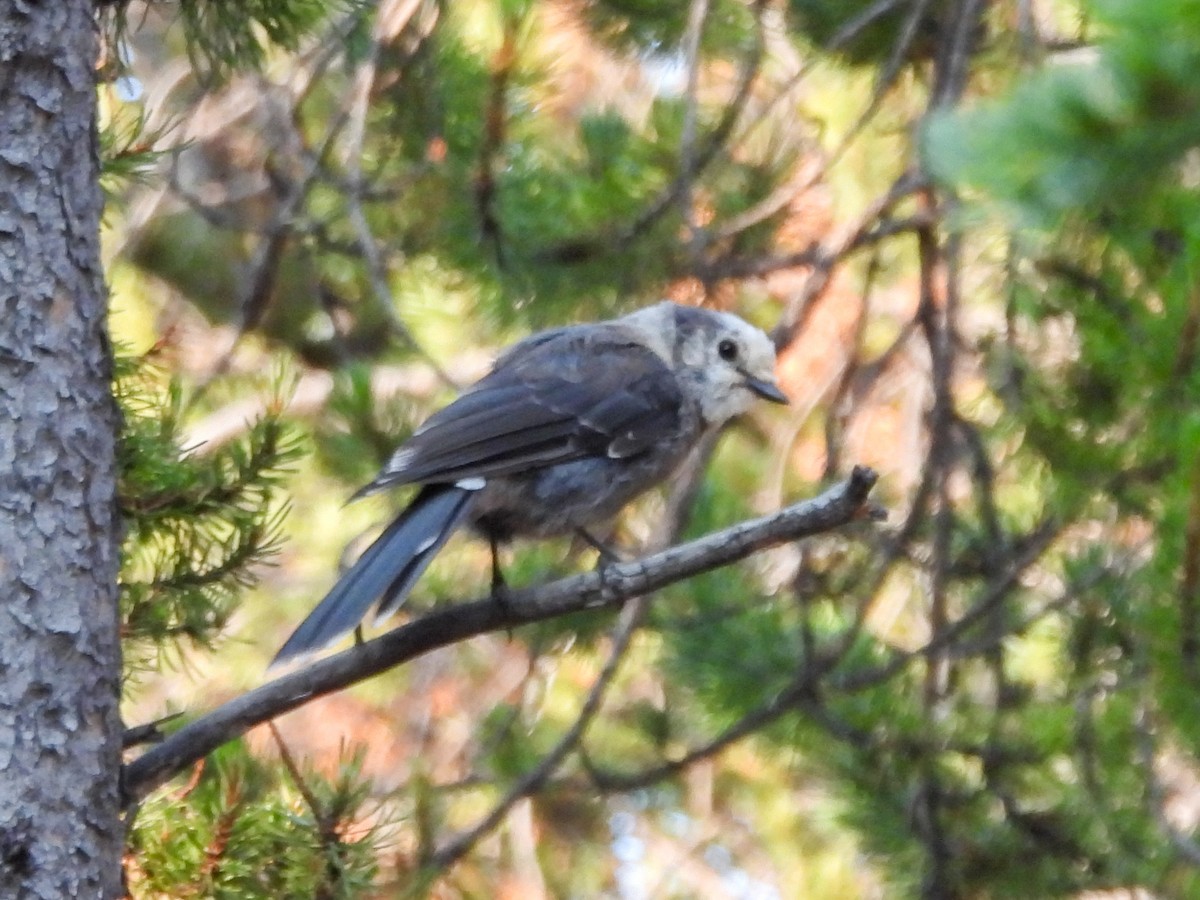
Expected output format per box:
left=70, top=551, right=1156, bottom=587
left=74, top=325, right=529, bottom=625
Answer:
left=115, top=355, right=300, bottom=667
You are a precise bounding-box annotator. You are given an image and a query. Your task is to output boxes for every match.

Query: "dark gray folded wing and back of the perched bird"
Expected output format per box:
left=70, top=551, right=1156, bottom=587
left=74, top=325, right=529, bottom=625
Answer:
left=365, top=326, right=683, bottom=492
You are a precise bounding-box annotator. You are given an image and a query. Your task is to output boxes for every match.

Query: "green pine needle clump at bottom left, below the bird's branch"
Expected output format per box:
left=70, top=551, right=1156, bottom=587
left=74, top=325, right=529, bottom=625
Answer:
left=126, top=742, right=380, bottom=900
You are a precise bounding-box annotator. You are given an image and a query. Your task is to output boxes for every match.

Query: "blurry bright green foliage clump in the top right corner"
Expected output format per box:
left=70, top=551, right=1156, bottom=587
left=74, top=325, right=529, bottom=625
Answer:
left=926, top=0, right=1200, bottom=227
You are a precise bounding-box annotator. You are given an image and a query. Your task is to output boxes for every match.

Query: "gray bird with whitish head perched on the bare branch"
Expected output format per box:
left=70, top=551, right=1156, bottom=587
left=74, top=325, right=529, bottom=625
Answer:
left=272, top=302, right=787, bottom=665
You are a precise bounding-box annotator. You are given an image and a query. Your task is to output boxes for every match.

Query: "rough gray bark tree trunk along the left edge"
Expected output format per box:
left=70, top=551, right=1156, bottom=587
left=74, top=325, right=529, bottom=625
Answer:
left=0, top=0, right=124, bottom=898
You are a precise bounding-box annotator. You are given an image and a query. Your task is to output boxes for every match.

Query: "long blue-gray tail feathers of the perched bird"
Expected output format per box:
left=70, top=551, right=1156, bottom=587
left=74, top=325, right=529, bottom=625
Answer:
left=271, top=485, right=476, bottom=667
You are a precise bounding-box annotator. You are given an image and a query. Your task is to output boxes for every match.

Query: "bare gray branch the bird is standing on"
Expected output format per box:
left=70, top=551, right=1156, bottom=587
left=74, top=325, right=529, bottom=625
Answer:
left=121, top=466, right=882, bottom=805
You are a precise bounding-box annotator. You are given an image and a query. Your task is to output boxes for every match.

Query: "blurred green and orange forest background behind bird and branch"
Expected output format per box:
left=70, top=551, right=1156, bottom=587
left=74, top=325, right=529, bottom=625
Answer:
left=108, top=0, right=1200, bottom=900
